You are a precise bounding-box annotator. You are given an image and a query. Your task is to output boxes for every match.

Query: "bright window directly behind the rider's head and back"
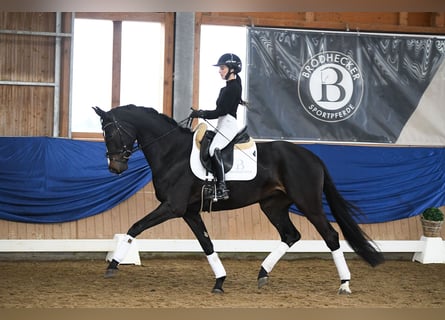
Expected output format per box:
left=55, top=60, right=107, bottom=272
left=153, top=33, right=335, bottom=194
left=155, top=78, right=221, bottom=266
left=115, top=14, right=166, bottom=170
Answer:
left=199, top=25, right=247, bottom=125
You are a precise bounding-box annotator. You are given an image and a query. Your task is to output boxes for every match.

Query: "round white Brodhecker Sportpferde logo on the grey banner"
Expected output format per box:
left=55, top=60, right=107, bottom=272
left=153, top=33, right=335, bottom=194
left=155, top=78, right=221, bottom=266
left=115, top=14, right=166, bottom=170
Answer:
left=298, top=51, right=363, bottom=122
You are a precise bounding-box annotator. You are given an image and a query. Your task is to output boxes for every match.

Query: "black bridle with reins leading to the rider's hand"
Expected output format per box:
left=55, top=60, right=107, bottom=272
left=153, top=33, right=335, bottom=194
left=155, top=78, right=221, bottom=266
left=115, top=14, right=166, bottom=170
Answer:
left=102, top=115, right=193, bottom=162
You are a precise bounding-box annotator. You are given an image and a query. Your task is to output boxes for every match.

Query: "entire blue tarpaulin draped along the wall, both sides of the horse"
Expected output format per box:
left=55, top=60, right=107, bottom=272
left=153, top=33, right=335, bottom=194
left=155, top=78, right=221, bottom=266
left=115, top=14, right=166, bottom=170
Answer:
left=0, top=137, right=445, bottom=223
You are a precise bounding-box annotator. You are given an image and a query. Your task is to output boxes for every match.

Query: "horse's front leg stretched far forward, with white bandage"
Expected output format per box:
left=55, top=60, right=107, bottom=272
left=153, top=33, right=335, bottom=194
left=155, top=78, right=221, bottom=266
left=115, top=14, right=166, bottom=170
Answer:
left=105, top=202, right=177, bottom=278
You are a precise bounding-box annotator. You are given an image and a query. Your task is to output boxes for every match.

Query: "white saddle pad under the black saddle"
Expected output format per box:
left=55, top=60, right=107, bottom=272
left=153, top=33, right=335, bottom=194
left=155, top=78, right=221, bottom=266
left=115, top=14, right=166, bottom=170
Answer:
left=190, top=123, right=257, bottom=181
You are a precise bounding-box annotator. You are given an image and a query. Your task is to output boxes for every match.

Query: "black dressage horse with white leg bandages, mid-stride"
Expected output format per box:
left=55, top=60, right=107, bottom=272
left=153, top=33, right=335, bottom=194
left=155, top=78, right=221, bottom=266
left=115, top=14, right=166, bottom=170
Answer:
left=94, top=105, right=384, bottom=293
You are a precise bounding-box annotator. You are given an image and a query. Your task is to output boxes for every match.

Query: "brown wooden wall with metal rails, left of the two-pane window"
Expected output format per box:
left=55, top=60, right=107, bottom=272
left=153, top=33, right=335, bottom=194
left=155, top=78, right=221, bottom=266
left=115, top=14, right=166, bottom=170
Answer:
left=0, top=12, right=55, bottom=136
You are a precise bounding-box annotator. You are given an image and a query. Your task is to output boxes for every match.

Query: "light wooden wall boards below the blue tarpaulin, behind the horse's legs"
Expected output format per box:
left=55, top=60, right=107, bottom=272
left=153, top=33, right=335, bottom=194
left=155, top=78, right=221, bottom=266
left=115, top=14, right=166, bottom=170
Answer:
left=0, top=183, right=445, bottom=240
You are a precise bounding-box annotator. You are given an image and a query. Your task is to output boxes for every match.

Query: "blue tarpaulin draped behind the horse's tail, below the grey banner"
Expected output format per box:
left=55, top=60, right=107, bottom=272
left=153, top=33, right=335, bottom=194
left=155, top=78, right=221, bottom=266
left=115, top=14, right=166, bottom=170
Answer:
left=291, top=144, right=445, bottom=223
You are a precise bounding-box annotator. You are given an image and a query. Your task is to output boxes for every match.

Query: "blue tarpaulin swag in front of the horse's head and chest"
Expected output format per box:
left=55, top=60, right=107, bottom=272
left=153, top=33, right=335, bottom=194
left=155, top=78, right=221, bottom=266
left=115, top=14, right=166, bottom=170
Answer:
left=0, top=137, right=151, bottom=223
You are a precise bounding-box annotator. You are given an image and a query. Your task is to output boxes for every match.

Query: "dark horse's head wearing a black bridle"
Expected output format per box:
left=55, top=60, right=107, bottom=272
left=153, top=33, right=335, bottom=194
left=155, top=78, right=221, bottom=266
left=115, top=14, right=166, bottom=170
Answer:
left=93, top=107, right=136, bottom=174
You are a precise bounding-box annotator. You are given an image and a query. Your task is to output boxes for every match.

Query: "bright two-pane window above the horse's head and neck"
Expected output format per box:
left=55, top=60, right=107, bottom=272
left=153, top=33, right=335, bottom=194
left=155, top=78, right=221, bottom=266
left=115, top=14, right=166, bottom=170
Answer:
left=71, top=14, right=164, bottom=137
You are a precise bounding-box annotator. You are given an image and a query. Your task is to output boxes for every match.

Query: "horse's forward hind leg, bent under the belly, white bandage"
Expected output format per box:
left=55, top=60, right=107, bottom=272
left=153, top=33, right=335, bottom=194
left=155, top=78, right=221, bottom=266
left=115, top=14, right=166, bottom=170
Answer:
left=258, top=195, right=301, bottom=288
